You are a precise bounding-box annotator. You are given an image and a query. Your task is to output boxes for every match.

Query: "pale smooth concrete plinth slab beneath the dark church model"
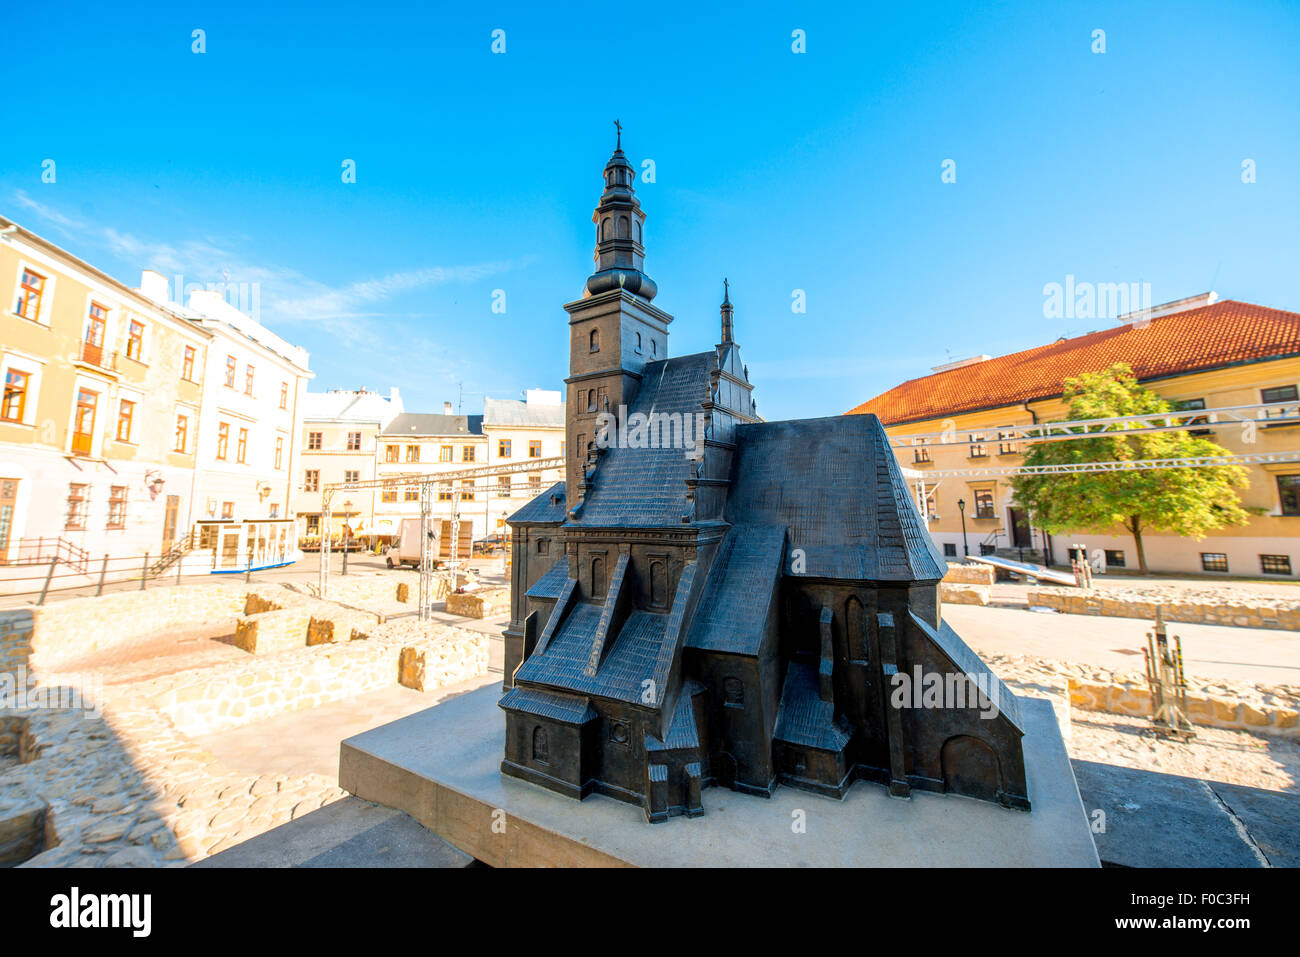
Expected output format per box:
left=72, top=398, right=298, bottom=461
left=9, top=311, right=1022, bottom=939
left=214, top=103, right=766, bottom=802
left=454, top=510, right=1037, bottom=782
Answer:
left=339, top=687, right=1100, bottom=867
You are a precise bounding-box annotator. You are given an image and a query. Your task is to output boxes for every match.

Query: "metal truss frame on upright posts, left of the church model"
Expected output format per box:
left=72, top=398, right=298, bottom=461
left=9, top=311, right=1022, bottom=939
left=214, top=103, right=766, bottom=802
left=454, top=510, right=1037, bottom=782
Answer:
left=317, top=456, right=564, bottom=620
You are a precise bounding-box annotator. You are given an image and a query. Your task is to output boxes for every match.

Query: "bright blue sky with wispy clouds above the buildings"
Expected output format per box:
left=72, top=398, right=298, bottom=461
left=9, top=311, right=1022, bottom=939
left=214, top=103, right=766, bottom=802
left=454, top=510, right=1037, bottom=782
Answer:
left=0, top=0, right=1300, bottom=419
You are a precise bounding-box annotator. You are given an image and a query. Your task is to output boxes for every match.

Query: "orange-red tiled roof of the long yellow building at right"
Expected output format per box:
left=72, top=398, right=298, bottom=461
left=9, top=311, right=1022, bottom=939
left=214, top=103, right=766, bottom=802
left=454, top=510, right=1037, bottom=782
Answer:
left=849, top=299, right=1300, bottom=425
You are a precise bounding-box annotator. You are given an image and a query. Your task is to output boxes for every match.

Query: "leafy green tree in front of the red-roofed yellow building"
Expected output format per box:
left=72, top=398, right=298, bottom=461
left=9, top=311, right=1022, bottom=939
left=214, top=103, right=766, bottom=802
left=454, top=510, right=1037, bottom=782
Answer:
left=1011, top=363, right=1252, bottom=575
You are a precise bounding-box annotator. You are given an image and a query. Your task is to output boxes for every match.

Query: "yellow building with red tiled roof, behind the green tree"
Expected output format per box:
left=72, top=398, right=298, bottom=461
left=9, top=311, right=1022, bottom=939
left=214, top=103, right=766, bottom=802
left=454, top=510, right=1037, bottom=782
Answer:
left=850, top=294, right=1300, bottom=577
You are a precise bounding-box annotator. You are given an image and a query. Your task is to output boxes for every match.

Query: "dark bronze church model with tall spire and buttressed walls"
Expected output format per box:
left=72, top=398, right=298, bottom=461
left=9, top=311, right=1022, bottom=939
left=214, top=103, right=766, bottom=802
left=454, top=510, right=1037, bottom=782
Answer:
left=501, top=132, right=1030, bottom=822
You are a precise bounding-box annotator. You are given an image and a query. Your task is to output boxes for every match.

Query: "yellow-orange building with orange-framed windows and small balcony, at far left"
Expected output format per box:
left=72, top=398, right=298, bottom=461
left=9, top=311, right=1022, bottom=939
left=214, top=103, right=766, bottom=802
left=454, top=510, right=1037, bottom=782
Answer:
left=0, top=217, right=212, bottom=564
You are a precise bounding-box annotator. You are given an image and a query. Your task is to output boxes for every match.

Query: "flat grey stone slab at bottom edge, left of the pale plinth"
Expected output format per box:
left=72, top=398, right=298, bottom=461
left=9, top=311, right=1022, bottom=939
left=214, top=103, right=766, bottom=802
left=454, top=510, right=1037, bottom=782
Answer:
left=190, top=797, right=475, bottom=867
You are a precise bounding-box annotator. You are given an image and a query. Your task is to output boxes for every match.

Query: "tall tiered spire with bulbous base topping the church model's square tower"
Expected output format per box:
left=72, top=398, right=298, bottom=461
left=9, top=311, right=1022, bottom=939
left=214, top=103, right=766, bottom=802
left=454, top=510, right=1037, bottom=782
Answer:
left=586, top=126, right=659, bottom=302
